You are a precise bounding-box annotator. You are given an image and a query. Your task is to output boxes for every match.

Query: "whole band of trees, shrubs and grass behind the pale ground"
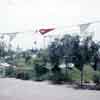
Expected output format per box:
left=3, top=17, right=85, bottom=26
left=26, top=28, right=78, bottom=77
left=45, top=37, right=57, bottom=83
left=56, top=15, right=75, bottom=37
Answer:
left=0, top=32, right=100, bottom=88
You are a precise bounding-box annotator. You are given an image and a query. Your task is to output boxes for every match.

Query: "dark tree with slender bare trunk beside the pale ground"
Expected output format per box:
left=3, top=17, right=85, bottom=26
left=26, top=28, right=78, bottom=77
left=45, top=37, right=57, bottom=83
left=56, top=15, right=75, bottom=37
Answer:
left=73, top=37, right=91, bottom=86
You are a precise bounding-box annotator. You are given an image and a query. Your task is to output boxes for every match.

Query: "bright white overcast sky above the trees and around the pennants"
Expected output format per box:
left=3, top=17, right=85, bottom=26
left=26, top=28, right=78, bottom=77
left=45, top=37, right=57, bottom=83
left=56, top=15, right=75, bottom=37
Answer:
left=0, top=0, right=100, bottom=48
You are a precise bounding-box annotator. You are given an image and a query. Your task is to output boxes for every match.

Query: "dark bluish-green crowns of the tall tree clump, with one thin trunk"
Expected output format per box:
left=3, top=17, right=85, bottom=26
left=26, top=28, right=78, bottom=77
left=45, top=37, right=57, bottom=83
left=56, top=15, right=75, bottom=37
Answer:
left=48, top=35, right=99, bottom=84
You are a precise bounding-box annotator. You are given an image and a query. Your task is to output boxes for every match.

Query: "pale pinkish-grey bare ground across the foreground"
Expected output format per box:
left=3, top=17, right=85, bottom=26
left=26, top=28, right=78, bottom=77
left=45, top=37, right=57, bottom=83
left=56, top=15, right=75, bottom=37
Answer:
left=0, top=78, right=100, bottom=100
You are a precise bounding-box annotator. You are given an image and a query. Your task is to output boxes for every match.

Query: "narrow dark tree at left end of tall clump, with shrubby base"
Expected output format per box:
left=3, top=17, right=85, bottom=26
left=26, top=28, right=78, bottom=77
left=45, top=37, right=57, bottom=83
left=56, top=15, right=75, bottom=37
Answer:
left=48, top=39, right=63, bottom=83
